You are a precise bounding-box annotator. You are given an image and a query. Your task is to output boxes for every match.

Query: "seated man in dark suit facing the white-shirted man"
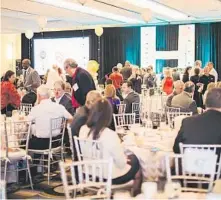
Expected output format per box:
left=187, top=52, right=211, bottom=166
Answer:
left=51, top=81, right=75, bottom=116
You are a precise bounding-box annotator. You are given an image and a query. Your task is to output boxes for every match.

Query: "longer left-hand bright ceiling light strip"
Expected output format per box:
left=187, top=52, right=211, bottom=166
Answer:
left=31, top=0, right=145, bottom=24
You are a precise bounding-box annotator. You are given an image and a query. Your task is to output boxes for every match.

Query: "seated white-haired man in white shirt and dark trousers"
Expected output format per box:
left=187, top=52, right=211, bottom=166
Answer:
left=29, top=85, right=72, bottom=150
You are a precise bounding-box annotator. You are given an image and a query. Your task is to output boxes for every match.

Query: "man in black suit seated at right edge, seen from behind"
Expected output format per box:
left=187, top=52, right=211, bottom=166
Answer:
left=173, top=88, right=221, bottom=153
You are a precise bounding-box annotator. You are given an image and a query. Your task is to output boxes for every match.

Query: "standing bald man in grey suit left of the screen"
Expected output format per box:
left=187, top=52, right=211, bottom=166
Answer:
left=22, top=59, right=41, bottom=92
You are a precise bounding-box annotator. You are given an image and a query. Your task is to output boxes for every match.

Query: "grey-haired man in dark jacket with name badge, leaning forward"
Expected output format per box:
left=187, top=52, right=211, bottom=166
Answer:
left=64, top=58, right=96, bottom=108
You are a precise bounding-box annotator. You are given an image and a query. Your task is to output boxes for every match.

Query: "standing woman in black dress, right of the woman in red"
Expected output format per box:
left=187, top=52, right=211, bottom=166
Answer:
left=190, top=68, right=203, bottom=107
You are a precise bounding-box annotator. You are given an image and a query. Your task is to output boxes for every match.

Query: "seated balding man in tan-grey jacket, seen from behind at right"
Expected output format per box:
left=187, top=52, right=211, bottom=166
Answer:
left=171, top=81, right=198, bottom=114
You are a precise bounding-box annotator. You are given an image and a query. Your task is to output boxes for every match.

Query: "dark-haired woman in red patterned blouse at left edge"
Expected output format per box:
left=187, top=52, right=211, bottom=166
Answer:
left=1, top=70, right=21, bottom=114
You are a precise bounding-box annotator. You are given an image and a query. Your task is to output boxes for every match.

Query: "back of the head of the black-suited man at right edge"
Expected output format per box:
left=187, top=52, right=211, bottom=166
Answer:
left=205, top=88, right=221, bottom=112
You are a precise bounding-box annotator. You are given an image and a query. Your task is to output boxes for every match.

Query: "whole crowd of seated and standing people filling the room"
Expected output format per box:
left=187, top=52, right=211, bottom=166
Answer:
left=1, top=56, right=221, bottom=193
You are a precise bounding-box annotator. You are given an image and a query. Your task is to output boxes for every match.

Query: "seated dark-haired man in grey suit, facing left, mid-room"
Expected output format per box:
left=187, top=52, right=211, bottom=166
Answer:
left=122, top=81, right=140, bottom=113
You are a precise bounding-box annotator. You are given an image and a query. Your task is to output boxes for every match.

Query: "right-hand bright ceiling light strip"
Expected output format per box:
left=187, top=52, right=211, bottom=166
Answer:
left=123, top=0, right=190, bottom=20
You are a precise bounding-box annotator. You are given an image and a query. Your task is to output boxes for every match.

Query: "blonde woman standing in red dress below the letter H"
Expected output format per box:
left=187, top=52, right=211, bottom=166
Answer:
left=162, top=68, right=173, bottom=95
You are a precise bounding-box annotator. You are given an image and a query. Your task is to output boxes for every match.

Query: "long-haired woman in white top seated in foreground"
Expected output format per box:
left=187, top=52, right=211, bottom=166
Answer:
left=79, top=99, right=142, bottom=195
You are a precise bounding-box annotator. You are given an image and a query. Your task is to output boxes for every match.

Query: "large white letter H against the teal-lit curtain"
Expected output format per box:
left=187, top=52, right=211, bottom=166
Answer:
left=141, top=24, right=195, bottom=70
